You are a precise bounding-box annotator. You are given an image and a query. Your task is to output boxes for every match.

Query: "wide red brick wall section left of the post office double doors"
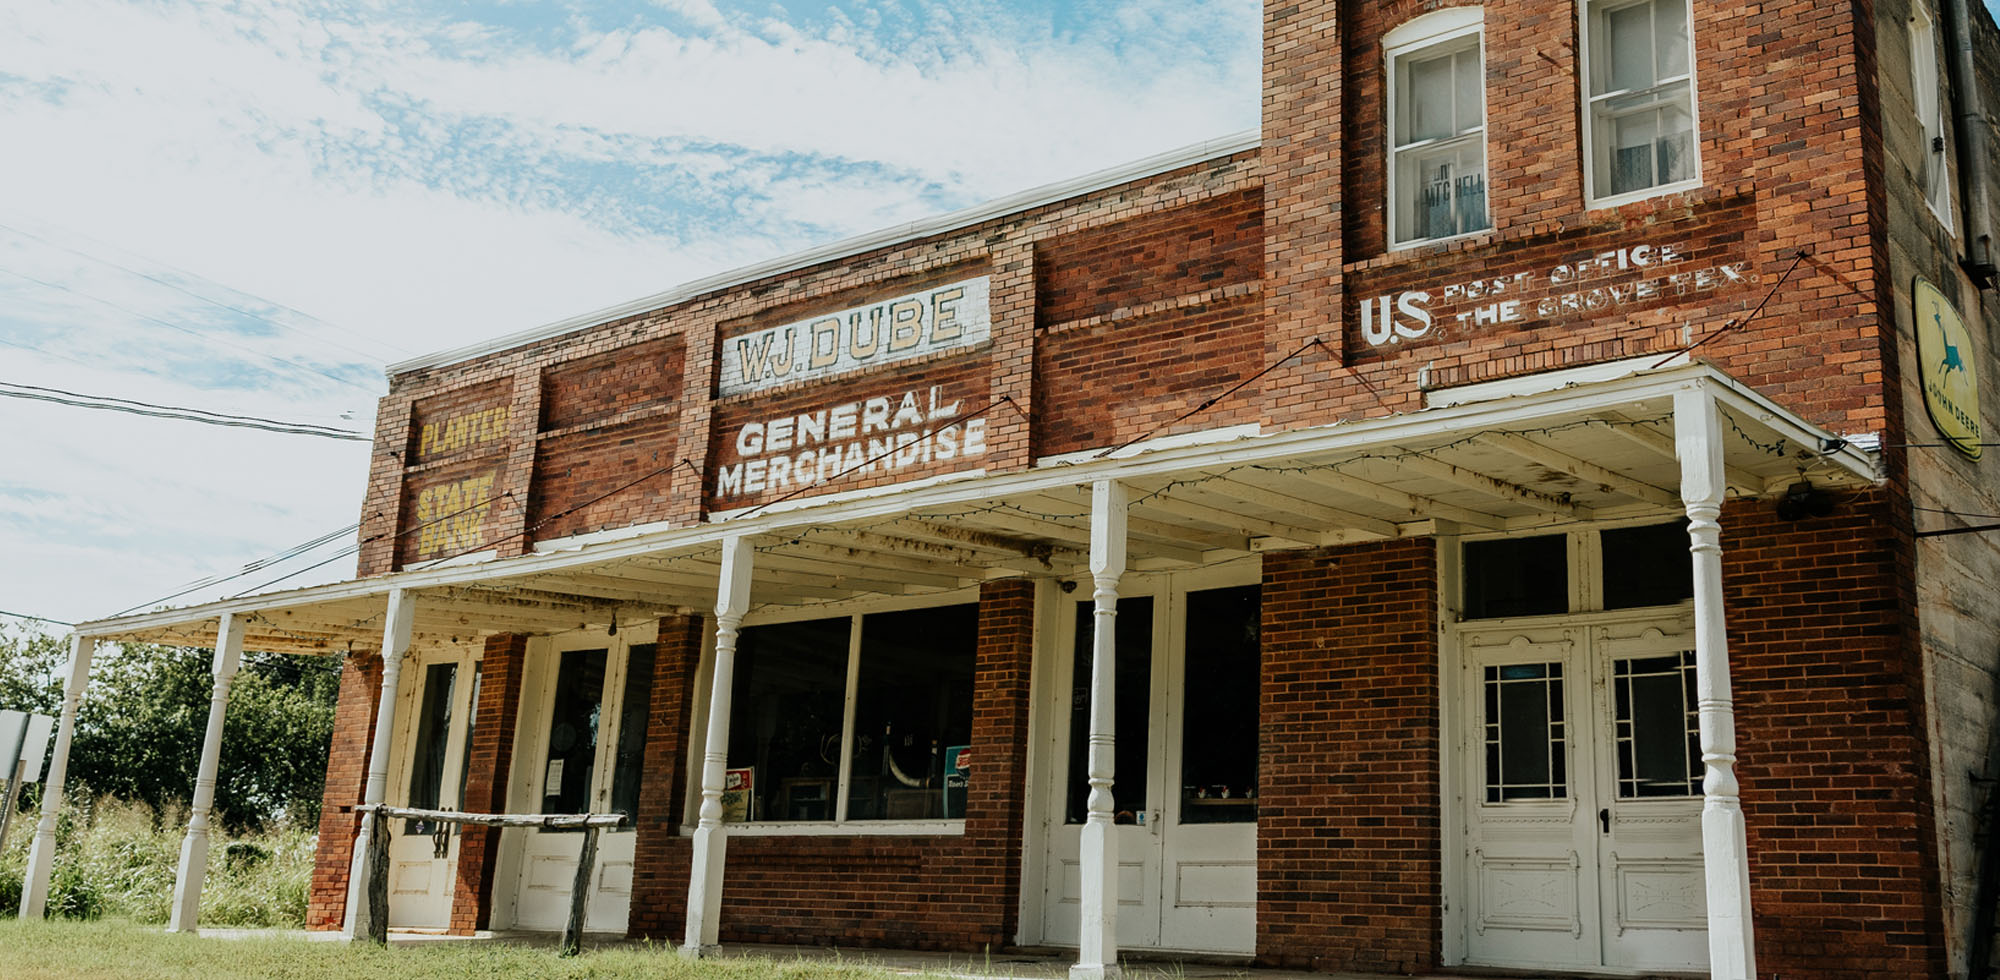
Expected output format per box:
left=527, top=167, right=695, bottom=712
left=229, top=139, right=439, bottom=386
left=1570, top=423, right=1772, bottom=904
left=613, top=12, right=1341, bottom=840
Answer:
left=1256, top=538, right=1444, bottom=974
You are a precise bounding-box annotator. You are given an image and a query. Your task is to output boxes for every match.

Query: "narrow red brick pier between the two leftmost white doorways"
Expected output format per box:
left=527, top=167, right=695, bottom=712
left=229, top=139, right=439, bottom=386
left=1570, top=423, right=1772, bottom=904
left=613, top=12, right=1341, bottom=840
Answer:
left=450, top=634, right=528, bottom=936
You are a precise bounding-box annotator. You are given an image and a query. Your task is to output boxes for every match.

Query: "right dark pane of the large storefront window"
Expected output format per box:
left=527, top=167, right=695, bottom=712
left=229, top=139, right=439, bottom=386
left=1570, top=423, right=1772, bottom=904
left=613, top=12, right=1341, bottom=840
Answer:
left=848, top=604, right=980, bottom=820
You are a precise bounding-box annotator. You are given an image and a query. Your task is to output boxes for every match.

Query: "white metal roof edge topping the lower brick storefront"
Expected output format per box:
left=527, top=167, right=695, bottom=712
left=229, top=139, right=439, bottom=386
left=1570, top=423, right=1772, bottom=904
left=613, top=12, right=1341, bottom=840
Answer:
left=384, top=130, right=1262, bottom=378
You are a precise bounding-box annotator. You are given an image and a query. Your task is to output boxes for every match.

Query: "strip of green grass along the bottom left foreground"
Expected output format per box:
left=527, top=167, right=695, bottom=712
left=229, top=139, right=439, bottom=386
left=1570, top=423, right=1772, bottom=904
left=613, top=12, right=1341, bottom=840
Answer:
left=0, top=920, right=932, bottom=980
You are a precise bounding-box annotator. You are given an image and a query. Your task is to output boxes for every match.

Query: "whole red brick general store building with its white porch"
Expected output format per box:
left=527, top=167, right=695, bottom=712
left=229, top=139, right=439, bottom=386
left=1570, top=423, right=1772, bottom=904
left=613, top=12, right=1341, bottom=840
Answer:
left=27, top=0, right=2000, bottom=978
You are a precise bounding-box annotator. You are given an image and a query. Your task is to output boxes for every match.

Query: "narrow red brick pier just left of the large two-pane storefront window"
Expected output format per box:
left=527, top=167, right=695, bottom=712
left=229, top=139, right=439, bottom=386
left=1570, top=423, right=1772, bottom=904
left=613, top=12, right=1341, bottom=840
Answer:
left=626, top=616, right=706, bottom=942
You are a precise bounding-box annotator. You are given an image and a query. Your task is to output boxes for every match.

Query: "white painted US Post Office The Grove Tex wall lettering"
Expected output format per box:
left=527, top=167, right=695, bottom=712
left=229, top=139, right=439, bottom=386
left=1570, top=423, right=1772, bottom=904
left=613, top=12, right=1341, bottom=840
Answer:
left=1358, top=242, right=1756, bottom=348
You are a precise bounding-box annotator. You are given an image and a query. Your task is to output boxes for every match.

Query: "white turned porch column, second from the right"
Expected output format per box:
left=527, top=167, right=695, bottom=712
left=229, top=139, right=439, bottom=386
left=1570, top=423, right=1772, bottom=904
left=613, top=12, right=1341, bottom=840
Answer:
left=1070, top=480, right=1126, bottom=980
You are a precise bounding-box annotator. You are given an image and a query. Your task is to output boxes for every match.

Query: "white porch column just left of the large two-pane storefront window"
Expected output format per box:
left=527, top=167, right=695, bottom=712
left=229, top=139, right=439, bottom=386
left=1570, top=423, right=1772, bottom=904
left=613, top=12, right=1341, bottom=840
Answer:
left=680, top=536, right=754, bottom=960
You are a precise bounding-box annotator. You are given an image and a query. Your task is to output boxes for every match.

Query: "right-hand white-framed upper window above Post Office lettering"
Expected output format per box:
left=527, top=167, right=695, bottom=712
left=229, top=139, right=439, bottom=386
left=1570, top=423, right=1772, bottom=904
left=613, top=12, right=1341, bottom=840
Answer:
left=1582, top=0, right=1702, bottom=206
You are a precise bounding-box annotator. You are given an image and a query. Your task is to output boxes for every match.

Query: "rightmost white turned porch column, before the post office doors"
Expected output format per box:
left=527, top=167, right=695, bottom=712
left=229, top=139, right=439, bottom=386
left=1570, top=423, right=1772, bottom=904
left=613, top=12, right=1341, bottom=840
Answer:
left=1674, top=388, right=1756, bottom=980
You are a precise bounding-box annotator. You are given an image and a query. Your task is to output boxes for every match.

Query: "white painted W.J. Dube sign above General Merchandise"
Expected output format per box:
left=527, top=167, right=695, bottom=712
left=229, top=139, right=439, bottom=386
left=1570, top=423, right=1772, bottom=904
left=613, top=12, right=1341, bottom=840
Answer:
left=716, top=276, right=992, bottom=396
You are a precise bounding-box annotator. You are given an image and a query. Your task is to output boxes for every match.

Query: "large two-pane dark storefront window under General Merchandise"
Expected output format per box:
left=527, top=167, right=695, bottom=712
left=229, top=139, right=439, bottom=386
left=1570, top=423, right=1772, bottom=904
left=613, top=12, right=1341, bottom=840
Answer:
left=728, top=604, right=978, bottom=822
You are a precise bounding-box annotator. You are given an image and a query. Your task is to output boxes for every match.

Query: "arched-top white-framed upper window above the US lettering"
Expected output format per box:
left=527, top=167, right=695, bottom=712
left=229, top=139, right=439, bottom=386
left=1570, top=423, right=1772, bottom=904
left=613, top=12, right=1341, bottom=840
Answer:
left=1382, top=6, right=1492, bottom=248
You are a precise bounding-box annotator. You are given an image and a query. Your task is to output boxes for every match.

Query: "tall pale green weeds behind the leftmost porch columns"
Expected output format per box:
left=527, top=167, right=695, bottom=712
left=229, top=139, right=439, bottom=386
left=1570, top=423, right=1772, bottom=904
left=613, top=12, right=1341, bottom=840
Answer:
left=0, top=798, right=314, bottom=928
